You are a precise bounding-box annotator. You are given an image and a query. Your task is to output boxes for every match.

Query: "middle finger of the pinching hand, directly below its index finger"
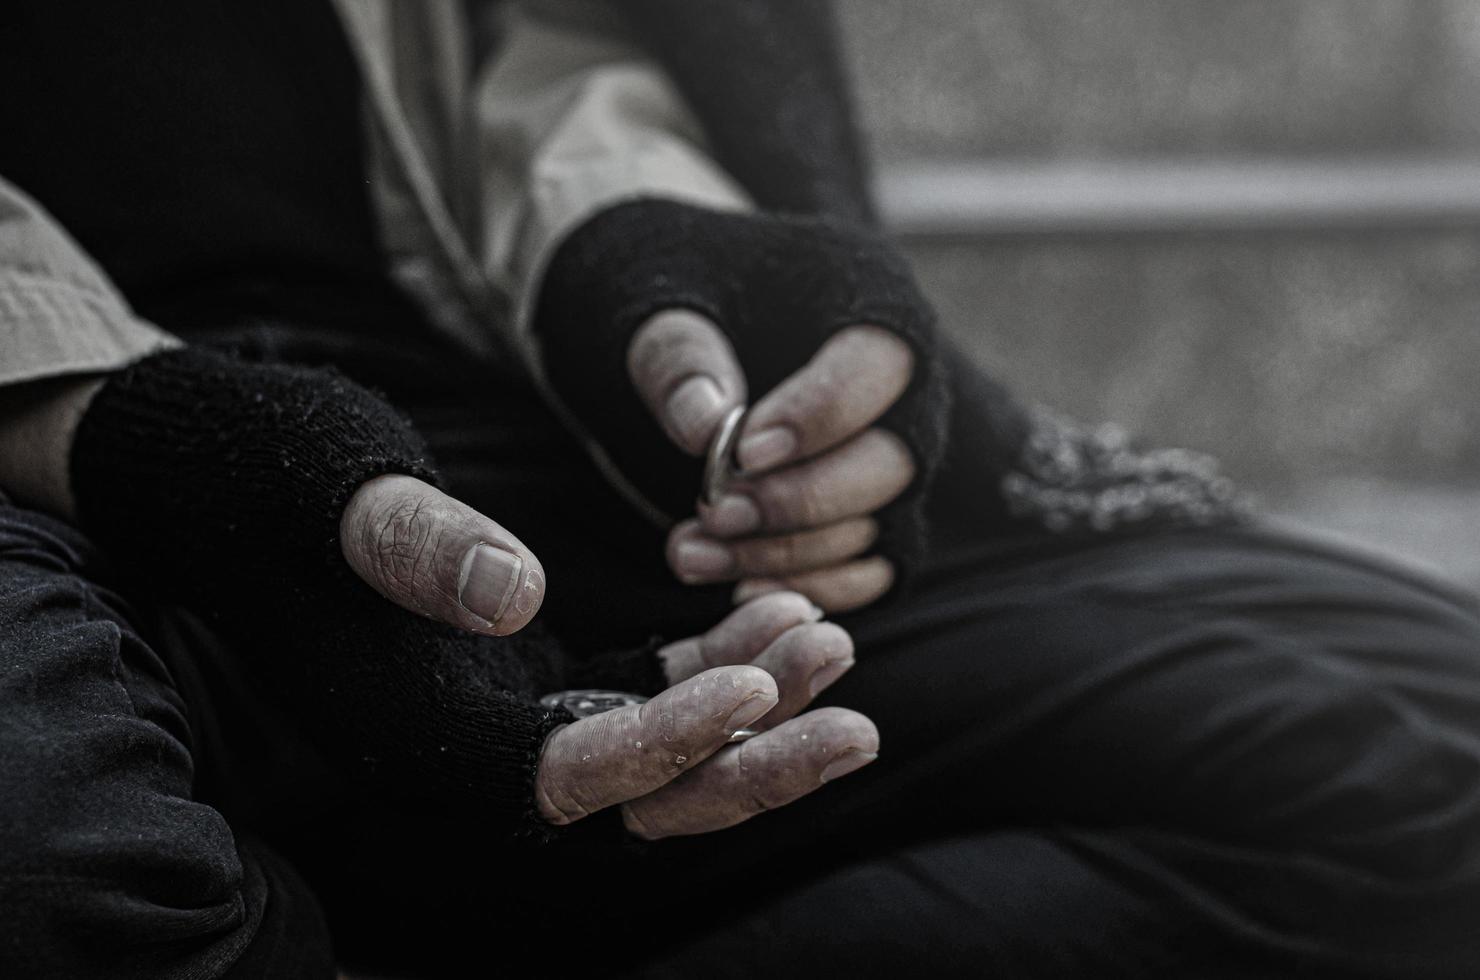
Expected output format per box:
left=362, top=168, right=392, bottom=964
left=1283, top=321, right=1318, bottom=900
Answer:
left=699, top=429, right=915, bottom=537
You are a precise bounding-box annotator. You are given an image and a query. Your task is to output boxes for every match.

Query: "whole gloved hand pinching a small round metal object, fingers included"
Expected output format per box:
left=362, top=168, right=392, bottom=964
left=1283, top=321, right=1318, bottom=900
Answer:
left=534, top=198, right=950, bottom=611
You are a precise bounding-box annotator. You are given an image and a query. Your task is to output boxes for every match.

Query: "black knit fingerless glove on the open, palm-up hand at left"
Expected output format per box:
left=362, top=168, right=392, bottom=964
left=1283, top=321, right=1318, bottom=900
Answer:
left=73, top=348, right=662, bottom=828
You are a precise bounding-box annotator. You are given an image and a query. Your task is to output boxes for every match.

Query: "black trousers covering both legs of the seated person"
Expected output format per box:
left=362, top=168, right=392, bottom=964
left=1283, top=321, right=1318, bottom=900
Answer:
left=0, top=336, right=1480, bottom=979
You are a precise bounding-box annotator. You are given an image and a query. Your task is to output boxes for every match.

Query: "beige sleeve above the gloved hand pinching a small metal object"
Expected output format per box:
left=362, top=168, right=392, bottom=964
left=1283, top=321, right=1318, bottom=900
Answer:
left=475, top=0, right=749, bottom=373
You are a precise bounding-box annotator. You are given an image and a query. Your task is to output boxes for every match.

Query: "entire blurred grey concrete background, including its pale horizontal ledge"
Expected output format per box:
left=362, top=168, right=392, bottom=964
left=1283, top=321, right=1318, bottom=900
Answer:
left=838, top=0, right=1480, bottom=588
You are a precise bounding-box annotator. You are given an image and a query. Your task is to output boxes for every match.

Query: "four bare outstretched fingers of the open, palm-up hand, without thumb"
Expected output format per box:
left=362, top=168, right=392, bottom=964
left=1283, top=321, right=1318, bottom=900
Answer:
left=534, top=592, right=879, bottom=839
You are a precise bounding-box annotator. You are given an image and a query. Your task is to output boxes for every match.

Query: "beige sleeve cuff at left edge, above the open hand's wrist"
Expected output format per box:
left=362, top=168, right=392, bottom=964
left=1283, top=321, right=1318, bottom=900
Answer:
left=0, top=179, right=178, bottom=385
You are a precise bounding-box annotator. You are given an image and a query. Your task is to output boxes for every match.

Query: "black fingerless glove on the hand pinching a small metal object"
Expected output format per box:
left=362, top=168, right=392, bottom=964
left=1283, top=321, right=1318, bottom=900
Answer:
left=536, top=200, right=947, bottom=586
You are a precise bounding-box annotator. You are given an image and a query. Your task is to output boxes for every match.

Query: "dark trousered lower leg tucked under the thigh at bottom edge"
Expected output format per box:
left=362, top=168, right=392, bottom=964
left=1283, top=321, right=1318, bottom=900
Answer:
left=636, top=830, right=1217, bottom=980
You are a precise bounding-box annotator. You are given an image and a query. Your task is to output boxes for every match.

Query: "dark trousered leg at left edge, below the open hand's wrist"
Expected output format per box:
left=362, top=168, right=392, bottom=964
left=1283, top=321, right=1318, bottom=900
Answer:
left=0, top=500, right=333, bottom=979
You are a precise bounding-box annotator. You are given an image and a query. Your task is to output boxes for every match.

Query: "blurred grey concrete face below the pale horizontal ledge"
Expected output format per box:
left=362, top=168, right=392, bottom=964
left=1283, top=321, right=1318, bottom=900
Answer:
left=909, top=232, right=1480, bottom=486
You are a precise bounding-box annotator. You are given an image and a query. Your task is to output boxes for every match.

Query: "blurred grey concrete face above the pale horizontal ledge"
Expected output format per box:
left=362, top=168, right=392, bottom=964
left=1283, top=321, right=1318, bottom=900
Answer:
left=838, top=0, right=1480, bottom=160
